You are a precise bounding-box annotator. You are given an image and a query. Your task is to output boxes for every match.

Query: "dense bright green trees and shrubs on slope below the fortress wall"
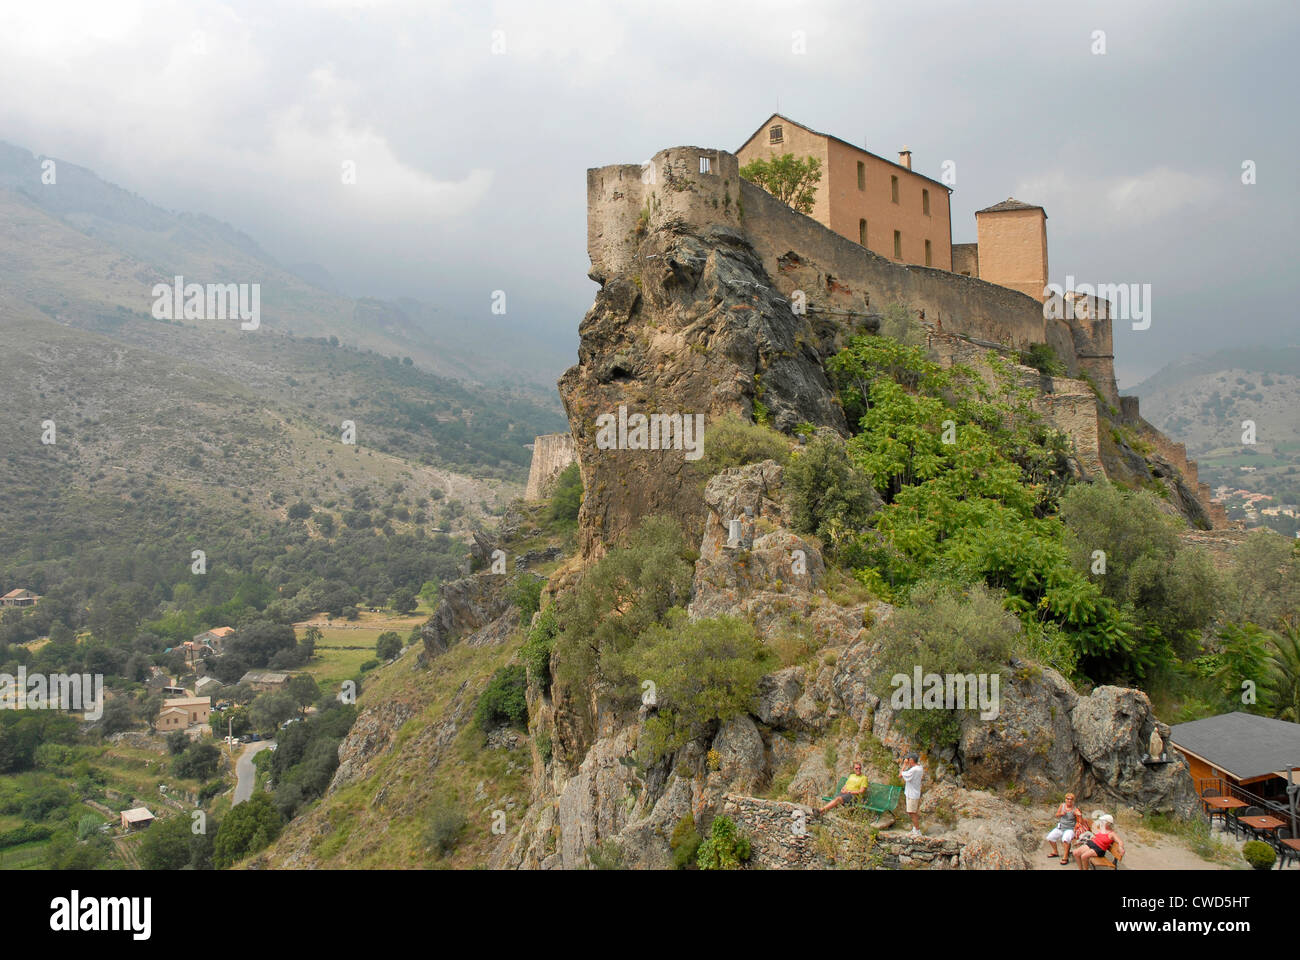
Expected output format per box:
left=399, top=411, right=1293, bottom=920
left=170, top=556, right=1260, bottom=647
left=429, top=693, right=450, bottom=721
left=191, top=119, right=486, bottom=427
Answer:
left=806, top=329, right=1300, bottom=713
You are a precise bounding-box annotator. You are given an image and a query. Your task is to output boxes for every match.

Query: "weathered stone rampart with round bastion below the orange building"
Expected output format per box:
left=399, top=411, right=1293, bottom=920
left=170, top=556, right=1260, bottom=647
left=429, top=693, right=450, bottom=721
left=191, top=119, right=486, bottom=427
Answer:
left=569, top=146, right=1218, bottom=524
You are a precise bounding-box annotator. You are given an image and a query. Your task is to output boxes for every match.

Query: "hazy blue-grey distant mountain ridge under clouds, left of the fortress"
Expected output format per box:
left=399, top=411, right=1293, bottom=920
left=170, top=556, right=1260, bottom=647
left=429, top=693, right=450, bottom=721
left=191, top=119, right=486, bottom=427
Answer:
left=0, top=142, right=572, bottom=397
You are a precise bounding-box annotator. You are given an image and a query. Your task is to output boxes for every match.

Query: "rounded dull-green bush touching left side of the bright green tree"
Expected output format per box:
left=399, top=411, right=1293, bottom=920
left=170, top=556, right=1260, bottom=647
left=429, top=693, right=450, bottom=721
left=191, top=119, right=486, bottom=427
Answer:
left=783, top=431, right=880, bottom=544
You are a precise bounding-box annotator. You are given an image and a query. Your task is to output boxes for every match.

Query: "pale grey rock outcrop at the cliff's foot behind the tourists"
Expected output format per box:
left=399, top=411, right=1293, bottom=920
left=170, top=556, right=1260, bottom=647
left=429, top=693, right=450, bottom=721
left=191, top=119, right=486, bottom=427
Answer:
left=502, top=460, right=1196, bottom=869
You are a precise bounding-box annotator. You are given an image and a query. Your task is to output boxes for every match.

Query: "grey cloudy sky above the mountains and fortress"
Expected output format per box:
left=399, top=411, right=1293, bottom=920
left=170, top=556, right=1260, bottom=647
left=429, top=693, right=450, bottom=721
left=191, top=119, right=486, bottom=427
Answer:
left=0, top=0, right=1300, bottom=384
